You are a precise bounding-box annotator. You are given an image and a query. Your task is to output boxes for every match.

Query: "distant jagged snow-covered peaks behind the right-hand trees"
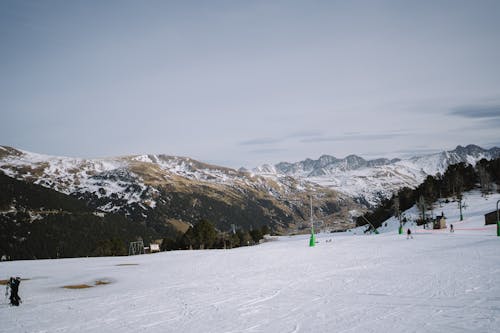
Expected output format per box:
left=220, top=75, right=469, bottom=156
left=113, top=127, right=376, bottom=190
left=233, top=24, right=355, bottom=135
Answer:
left=252, top=145, right=500, bottom=206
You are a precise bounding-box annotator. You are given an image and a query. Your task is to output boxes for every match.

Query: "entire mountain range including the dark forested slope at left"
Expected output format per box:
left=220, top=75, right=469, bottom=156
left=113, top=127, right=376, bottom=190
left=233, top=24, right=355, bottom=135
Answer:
left=0, top=145, right=500, bottom=258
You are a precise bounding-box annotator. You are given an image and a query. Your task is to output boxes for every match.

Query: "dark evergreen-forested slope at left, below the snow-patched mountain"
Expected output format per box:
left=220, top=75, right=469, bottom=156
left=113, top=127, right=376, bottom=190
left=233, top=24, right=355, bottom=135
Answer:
left=0, top=173, right=159, bottom=260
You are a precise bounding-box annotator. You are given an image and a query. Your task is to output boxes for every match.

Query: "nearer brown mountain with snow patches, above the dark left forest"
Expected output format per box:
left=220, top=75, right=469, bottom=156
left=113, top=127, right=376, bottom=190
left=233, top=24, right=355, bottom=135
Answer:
left=0, top=146, right=360, bottom=230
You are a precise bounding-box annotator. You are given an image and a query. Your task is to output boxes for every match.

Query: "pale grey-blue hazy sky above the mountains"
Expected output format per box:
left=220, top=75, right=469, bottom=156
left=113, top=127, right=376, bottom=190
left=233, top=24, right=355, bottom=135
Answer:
left=0, top=0, right=500, bottom=168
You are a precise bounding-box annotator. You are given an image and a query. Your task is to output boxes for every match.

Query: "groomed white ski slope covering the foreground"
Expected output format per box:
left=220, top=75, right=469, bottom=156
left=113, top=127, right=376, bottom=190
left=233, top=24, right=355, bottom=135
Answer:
left=0, top=192, right=500, bottom=333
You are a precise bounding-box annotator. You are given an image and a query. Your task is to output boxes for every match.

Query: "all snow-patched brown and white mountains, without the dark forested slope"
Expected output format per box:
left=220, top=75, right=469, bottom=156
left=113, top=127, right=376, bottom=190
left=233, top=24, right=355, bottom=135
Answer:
left=0, top=145, right=500, bottom=236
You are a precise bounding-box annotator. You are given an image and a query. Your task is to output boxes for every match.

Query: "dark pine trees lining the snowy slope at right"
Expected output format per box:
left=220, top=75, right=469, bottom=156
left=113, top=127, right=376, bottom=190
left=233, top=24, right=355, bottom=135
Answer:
left=356, top=158, right=500, bottom=228
